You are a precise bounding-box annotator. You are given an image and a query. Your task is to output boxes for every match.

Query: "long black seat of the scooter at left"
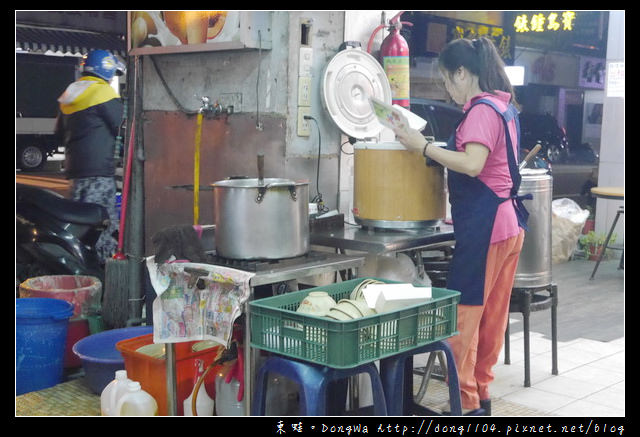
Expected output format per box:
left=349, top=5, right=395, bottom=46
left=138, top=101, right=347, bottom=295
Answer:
left=16, top=184, right=109, bottom=226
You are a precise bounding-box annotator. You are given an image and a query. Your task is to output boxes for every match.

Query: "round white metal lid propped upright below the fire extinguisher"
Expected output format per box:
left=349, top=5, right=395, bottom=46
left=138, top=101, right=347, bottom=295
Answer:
left=322, top=48, right=391, bottom=139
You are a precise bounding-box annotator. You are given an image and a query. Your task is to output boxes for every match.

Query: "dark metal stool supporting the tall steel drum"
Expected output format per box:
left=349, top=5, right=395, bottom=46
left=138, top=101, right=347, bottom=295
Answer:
left=504, top=284, right=558, bottom=387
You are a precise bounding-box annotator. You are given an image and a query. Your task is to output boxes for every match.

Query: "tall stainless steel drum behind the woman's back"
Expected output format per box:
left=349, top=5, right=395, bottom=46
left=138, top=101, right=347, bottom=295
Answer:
left=513, top=169, right=553, bottom=288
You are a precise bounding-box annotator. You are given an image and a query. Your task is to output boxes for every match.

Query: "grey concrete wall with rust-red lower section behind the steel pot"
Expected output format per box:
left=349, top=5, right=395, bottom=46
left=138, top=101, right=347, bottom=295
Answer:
left=142, top=11, right=350, bottom=252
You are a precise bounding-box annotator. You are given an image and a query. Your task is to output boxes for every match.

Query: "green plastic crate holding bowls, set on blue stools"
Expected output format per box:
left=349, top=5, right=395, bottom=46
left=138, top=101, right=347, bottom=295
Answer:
left=249, top=278, right=460, bottom=368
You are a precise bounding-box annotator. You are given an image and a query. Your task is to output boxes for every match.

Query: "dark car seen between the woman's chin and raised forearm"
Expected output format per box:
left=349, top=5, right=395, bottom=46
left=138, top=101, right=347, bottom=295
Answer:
left=410, top=97, right=463, bottom=143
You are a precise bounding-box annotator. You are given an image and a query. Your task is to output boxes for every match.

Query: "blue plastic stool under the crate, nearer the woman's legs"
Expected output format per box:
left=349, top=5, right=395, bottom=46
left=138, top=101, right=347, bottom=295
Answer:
left=380, top=341, right=462, bottom=416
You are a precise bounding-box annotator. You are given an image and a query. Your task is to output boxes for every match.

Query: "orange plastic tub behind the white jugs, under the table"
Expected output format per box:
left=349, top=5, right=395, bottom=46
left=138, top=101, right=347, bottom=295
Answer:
left=116, top=334, right=222, bottom=416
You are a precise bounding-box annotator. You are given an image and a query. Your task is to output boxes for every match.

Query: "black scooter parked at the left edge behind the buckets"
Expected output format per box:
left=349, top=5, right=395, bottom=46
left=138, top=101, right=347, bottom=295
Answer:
left=16, top=184, right=109, bottom=282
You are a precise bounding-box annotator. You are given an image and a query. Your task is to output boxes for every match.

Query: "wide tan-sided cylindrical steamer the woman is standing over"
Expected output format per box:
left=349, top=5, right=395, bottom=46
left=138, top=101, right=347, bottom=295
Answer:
left=353, top=142, right=446, bottom=228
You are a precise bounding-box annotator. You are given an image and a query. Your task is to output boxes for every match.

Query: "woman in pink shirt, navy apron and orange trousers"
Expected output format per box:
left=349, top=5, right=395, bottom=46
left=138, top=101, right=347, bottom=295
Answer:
left=396, top=38, right=528, bottom=414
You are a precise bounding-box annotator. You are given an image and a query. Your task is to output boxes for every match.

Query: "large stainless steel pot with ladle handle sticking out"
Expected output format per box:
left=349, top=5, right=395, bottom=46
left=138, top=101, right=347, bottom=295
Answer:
left=212, top=178, right=309, bottom=259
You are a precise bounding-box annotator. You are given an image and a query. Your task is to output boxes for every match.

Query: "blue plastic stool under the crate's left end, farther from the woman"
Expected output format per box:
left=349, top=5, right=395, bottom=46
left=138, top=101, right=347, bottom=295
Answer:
left=251, top=355, right=387, bottom=416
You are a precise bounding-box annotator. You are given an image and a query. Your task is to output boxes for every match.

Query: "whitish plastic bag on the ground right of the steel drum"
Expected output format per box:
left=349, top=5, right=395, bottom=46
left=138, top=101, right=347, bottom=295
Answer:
left=551, top=198, right=589, bottom=264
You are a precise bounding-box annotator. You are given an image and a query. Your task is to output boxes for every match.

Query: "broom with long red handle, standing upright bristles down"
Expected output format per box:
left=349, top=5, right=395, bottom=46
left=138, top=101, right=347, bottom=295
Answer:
left=102, top=115, right=135, bottom=328
